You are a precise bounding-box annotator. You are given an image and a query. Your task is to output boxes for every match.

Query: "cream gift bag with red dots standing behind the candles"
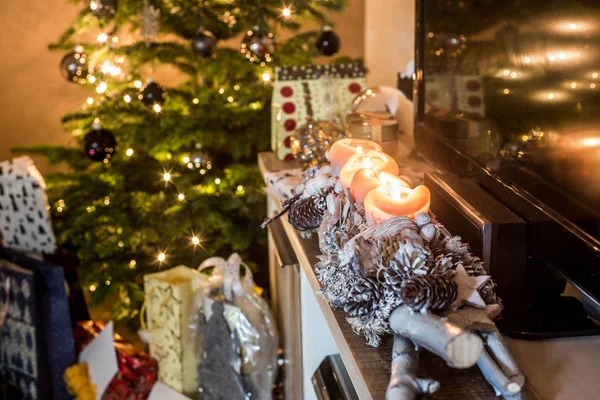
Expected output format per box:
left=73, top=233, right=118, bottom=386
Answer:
left=271, top=62, right=366, bottom=160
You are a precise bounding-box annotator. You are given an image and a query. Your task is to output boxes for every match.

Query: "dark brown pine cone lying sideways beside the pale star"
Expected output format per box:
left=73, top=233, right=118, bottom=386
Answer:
left=399, top=275, right=458, bottom=311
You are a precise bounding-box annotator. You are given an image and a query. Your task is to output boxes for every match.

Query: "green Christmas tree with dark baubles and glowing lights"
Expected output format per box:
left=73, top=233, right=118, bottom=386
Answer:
left=20, top=0, right=346, bottom=321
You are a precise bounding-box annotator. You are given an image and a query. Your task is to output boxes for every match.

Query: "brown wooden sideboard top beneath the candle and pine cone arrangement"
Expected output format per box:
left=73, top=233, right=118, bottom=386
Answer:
left=259, top=153, right=541, bottom=400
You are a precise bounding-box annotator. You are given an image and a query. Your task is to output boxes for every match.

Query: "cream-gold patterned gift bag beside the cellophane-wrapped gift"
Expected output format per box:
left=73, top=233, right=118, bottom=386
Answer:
left=144, top=266, right=205, bottom=396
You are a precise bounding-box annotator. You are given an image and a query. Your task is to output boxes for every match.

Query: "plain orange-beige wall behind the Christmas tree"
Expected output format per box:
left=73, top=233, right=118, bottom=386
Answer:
left=0, top=0, right=364, bottom=171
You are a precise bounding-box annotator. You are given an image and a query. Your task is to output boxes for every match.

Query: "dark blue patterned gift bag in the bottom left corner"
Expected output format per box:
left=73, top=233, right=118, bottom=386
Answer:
left=0, top=248, right=76, bottom=400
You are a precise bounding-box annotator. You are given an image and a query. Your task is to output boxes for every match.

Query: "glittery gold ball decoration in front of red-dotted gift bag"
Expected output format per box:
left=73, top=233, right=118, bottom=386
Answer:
left=290, top=120, right=345, bottom=168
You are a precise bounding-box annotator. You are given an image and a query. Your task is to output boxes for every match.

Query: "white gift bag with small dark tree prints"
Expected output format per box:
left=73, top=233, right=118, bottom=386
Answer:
left=0, top=156, right=56, bottom=253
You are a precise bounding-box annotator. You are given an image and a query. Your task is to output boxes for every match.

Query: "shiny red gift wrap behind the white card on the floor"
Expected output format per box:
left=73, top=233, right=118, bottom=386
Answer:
left=73, top=321, right=158, bottom=400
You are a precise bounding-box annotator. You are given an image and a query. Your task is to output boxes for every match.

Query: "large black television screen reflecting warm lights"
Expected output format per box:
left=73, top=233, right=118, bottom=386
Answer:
left=415, top=0, right=600, bottom=299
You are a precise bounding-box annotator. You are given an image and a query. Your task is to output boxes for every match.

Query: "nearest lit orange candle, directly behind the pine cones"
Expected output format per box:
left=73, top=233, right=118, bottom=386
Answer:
left=364, top=182, right=431, bottom=225
